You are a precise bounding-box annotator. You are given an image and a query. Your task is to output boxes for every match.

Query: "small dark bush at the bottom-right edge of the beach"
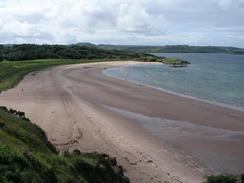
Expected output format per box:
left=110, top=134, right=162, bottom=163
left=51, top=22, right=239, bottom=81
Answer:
left=204, top=175, right=239, bottom=183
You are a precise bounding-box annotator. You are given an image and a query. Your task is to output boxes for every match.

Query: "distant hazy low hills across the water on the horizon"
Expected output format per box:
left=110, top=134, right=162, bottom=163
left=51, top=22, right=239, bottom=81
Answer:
left=97, top=44, right=244, bottom=54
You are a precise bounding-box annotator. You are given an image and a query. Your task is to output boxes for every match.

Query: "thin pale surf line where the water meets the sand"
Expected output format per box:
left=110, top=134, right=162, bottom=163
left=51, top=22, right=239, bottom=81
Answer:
left=102, top=62, right=244, bottom=112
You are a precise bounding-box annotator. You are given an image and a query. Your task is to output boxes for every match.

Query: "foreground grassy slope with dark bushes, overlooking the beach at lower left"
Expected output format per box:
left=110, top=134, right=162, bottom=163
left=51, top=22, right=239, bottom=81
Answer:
left=0, top=107, right=129, bottom=183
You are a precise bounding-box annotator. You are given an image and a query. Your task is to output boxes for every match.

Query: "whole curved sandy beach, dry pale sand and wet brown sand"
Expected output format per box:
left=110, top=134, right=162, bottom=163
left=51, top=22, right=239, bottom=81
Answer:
left=0, top=61, right=244, bottom=183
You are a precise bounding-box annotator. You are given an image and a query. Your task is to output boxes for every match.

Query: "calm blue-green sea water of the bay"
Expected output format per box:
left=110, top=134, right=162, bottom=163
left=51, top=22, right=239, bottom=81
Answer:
left=104, top=53, right=244, bottom=110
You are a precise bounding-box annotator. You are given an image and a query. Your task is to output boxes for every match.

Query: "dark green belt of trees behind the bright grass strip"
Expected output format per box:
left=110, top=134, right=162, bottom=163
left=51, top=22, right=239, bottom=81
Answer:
left=0, top=44, right=145, bottom=61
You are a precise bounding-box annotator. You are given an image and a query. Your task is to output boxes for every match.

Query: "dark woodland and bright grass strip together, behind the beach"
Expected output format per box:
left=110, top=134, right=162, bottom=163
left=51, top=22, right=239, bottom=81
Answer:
left=0, top=43, right=151, bottom=92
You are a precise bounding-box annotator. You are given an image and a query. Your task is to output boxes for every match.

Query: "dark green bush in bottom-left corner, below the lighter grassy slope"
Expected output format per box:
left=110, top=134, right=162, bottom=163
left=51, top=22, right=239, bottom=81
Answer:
left=0, top=146, right=57, bottom=183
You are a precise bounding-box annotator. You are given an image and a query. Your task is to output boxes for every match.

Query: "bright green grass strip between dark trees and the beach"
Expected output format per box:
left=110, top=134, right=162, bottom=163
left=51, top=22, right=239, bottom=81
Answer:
left=0, top=59, right=120, bottom=92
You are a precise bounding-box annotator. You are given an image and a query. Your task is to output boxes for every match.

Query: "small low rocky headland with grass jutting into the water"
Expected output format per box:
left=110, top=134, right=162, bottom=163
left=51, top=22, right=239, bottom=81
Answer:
left=136, top=56, right=190, bottom=68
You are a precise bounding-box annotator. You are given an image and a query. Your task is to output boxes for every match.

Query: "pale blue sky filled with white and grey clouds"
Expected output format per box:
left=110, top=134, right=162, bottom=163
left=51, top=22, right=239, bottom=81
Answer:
left=0, top=0, right=244, bottom=47
